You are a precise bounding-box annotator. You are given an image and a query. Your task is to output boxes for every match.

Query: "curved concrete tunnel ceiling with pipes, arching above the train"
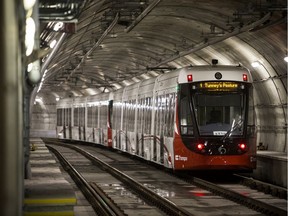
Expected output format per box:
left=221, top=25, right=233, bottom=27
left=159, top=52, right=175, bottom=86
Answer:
left=37, top=0, right=287, bottom=98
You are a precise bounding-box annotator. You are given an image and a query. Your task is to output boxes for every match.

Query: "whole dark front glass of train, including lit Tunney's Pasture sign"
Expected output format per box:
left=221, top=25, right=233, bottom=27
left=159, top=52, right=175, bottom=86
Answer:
left=179, top=82, right=247, bottom=137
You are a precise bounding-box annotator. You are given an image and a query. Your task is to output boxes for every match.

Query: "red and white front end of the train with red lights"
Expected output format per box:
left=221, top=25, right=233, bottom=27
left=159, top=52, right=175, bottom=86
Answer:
left=174, top=63, right=256, bottom=171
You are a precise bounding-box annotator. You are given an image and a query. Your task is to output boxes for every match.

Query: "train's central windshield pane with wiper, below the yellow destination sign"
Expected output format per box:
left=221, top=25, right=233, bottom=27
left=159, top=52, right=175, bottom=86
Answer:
left=192, top=93, right=244, bottom=136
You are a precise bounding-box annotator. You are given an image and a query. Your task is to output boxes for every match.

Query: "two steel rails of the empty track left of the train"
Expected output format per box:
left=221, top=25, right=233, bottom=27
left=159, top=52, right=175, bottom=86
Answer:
left=47, top=145, right=193, bottom=216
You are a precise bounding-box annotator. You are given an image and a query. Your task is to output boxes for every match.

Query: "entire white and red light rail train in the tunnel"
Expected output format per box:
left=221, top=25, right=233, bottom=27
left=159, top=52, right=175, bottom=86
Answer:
left=57, top=61, right=256, bottom=171
